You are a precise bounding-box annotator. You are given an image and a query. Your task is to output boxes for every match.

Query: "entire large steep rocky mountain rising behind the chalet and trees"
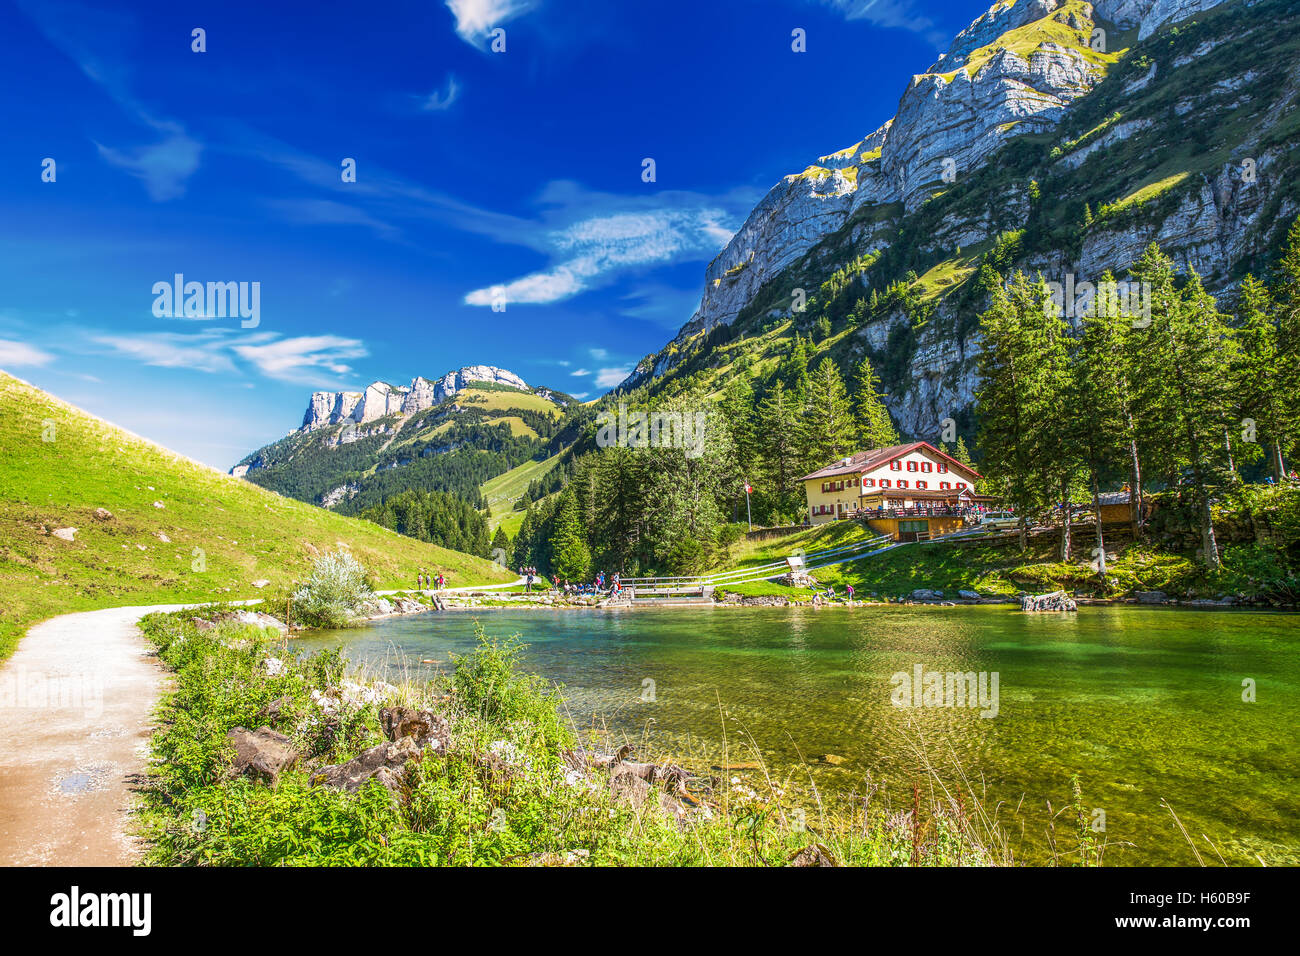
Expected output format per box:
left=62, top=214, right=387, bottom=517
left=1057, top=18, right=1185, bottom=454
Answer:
left=620, top=0, right=1300, bottom=438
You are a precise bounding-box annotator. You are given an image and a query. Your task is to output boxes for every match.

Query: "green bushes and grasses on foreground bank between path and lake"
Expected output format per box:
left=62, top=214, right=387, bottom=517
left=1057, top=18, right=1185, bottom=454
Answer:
left=139, top=611, right=1010, bottom=866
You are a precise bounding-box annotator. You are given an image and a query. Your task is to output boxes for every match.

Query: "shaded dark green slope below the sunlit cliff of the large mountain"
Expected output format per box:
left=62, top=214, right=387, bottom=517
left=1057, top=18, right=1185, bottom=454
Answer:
left=621, top=0, right=1300, bottom=440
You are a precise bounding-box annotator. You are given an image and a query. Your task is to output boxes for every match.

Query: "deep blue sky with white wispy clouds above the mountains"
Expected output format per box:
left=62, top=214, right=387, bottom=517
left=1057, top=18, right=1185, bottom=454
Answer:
left=0, top=0, right=987, bottom=468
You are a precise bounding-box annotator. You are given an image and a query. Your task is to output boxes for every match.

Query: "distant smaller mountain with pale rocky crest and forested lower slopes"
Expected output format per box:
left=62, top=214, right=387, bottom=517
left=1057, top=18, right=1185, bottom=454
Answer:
left=231, top=365, right=577, bottom=514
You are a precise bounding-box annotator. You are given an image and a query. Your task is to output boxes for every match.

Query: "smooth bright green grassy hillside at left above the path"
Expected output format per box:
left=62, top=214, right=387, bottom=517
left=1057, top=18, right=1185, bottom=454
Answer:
left=0, top=372, right=507, bottom=658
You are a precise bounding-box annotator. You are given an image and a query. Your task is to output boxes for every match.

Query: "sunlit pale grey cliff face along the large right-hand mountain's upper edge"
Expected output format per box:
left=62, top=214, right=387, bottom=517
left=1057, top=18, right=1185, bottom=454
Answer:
left=655, top=0, right=1102, bottom=356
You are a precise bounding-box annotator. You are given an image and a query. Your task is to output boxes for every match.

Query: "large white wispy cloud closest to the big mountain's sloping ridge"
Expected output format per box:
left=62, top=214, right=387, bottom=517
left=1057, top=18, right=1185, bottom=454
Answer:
left=465, top=181, right=754, bottom=306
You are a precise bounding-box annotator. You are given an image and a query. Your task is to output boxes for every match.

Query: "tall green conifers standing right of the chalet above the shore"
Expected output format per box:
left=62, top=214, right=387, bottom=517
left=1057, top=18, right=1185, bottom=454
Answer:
left=976, top=220, right=1300, bottom=574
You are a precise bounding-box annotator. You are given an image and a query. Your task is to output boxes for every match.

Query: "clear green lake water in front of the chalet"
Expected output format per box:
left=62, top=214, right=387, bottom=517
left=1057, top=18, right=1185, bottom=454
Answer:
left=296, top=607, right=1300, bottom=864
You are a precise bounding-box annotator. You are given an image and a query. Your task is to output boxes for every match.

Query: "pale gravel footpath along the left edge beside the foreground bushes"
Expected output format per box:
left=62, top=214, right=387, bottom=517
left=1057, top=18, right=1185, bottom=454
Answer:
left=0, top=605, right=187, bottom=866
